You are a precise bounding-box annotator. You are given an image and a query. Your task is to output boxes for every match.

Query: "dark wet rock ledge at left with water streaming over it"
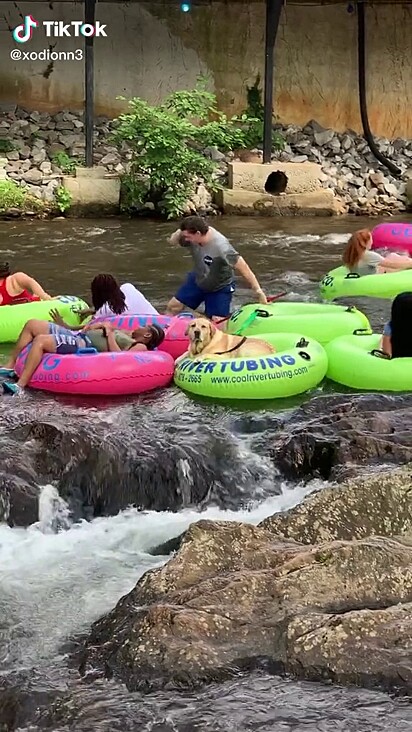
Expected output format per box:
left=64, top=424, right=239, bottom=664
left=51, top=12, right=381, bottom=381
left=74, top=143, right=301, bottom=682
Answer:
left=0, top=412, right=239, bottom=526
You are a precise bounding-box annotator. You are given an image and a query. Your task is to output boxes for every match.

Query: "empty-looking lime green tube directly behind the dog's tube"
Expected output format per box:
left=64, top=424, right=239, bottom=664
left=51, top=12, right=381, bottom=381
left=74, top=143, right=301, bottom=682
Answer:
left=225, top=302, right=370, bottom=345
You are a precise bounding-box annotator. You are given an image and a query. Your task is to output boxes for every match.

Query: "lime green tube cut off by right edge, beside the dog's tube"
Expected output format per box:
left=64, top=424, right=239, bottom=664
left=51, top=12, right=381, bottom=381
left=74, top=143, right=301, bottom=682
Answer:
left=325, top=333, right=412, bottom=392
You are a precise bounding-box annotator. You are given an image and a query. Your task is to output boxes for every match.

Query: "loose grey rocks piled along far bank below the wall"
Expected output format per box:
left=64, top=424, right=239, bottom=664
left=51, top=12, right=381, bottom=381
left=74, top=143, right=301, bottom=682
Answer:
left=0, top=107, right=412, bottom=218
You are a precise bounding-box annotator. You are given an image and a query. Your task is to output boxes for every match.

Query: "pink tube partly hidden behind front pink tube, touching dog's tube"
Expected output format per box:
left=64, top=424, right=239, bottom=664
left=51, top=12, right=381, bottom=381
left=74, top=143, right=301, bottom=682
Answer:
left=93, top=313, right=193, bottom=358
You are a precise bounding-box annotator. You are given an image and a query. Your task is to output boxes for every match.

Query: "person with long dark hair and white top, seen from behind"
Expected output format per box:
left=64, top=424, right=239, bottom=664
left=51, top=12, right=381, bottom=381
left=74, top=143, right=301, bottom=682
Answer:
left=80, top=274, right=159, bottom=321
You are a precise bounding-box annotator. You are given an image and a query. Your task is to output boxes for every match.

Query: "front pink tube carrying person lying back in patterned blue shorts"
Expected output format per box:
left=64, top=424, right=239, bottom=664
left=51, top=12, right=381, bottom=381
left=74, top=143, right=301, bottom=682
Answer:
left=15, top=346, right=174, bottom=396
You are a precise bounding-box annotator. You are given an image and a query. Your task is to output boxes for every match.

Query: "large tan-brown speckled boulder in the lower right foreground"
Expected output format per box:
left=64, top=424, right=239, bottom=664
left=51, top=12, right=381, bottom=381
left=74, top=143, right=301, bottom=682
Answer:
left=79, top=472, right=412, bottom=693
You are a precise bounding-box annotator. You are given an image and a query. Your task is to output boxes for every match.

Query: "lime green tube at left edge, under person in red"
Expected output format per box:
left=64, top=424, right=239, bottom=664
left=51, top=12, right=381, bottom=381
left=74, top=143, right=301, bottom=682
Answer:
left=0, top=295, right=89, bottom=343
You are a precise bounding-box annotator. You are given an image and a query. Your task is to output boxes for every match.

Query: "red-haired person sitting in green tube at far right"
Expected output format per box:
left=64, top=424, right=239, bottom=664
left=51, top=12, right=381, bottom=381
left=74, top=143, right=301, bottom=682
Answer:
left=342, top=229, right=412, bottom=276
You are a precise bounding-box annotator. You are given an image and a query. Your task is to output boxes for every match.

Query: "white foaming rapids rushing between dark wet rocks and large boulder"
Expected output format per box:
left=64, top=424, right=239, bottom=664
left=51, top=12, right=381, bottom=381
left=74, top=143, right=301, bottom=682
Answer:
left=0, top=481, right=322, bottom=670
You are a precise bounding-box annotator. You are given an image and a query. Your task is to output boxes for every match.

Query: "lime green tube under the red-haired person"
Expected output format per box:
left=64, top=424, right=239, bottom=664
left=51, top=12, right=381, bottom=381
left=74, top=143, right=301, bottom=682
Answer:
left=320, top=267, right=412, bottom=300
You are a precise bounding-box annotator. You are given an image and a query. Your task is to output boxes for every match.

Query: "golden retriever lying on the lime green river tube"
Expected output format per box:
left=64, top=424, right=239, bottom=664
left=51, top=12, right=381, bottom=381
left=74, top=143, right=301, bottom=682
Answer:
left=176, top=318, right=275, bottom=363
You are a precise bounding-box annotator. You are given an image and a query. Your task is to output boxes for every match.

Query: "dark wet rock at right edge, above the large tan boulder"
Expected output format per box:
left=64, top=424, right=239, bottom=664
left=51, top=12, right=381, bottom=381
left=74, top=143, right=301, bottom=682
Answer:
left=271, top=395, right=412, bottom=480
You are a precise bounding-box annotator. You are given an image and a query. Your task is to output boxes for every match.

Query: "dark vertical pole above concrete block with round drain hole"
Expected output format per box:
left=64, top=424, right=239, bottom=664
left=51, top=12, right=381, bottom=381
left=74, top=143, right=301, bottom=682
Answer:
left=263, top=0, right=283, bottom=163
